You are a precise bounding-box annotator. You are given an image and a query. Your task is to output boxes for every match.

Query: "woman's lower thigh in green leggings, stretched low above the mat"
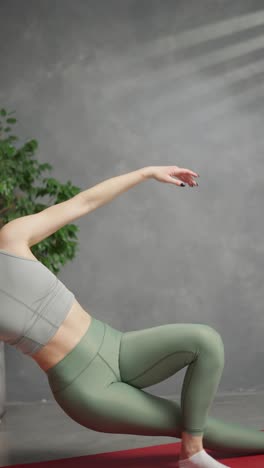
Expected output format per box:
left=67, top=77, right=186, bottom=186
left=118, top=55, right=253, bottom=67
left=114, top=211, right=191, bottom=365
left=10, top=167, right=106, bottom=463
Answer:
left=51, top=354, right=184, bottom=438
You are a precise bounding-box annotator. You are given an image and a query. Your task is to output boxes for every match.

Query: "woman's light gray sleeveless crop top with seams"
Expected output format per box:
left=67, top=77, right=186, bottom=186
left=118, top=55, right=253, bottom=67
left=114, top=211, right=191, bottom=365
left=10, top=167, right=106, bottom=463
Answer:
left=0, top=249, right=75, bottom=355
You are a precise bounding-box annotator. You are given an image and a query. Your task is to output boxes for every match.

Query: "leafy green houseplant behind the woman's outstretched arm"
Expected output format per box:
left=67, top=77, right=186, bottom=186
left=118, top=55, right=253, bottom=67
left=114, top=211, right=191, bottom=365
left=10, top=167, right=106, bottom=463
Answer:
left=0, top=108, right=81, bottom=274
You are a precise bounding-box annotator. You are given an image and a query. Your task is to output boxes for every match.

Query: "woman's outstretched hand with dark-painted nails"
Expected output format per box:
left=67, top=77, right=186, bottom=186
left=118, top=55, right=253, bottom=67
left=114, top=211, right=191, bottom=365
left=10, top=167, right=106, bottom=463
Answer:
left=151, top=166, right=200, bottom=187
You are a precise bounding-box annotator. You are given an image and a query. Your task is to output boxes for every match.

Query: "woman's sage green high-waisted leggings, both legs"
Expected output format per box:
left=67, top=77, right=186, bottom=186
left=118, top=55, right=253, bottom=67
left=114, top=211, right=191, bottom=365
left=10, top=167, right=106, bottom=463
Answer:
left=46, top=317, right=264, bottom=454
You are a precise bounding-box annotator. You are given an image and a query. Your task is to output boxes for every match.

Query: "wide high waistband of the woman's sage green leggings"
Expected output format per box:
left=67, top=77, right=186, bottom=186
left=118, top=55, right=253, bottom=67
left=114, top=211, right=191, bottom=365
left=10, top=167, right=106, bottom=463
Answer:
left=46, top=316, right=106, bottom=392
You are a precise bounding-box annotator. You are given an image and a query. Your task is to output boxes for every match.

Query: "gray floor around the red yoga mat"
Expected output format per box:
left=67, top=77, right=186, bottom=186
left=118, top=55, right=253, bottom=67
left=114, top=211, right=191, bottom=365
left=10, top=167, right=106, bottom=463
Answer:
left=0, top=393, right=264, bottom=466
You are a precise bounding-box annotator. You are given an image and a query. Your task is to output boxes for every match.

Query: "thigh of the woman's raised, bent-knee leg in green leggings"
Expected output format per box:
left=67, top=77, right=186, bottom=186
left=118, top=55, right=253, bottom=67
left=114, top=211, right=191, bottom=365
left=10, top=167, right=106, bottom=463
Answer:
left=119, top=323, right=218, bottom=388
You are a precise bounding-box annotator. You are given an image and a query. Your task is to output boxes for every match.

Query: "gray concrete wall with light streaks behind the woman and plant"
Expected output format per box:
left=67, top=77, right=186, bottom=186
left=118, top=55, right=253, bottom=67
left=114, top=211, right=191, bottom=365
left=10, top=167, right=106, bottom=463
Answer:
left=0, top=0, right=264, bottom=401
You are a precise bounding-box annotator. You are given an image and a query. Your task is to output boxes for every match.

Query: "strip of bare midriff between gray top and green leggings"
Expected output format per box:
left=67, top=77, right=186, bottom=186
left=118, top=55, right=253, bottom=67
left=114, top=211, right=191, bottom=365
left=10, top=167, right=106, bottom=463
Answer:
left=29, top=299, right=91, bottom=372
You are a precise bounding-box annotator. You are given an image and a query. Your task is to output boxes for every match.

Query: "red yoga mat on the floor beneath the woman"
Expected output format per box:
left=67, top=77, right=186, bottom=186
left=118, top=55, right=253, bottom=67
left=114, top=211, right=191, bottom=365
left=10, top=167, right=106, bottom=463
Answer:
left=4, top=442, right=264, bottom=468
